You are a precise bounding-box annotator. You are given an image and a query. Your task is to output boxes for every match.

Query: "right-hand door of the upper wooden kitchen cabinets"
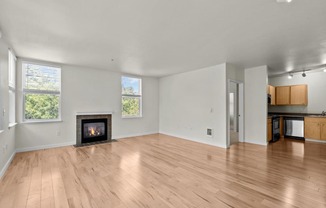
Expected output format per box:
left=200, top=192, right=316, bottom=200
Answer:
left=290, top=85, right=308, bottom=105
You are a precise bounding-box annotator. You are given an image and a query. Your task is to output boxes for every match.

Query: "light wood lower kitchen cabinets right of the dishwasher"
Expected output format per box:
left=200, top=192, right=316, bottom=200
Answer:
left=304, top=117, right=326, bottom=140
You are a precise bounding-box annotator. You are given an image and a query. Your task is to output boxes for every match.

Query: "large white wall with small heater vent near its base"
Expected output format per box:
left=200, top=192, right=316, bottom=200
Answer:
left=160, top=64, right=227, bottom=148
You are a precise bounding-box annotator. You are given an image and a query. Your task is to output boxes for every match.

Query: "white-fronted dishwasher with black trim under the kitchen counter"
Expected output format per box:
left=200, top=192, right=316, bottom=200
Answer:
left=284, top=116, right=304, bottom=140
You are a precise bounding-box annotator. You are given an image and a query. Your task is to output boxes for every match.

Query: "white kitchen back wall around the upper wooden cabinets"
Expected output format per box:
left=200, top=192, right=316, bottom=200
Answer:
left=268, top=71, right=326, bottom=113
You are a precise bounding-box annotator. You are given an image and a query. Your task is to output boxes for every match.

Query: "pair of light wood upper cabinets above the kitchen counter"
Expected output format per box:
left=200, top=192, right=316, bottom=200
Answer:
left=276, top=85, right=308, bottom=105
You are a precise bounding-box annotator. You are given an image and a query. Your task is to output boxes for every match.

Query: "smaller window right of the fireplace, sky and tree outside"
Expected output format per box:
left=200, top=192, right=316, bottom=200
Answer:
left=121, top=77, right=142, bottom=118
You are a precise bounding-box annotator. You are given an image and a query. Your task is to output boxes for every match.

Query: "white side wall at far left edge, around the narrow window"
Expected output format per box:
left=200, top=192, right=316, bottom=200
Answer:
left=0, top=39, right=16, bottom=178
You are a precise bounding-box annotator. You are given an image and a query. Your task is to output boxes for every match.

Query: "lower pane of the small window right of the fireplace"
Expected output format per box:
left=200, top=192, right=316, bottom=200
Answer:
left=122, top=97, right=140, bottom=117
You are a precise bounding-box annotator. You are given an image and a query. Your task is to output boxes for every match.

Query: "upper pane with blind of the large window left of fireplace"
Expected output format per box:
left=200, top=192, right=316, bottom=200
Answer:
left=23, top=63, right=61, bottom=91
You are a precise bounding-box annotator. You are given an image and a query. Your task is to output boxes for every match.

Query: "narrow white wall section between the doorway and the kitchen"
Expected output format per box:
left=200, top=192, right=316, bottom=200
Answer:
left=245, top=66, right=267, bottom=145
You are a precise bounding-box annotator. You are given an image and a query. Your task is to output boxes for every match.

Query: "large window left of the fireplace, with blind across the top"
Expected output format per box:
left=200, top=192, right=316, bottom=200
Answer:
left=23, top=63, right=61, bottom=122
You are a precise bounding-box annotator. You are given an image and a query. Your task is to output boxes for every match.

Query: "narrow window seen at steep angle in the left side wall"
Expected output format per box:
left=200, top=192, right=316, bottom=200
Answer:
left=8, top=50, right=17, bottom=126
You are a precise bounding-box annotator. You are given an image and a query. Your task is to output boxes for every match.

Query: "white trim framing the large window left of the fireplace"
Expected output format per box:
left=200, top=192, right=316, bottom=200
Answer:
left=21, top=61, right=62, bottom=124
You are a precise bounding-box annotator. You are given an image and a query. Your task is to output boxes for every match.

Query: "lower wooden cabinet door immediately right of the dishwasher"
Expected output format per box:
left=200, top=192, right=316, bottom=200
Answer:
left=304, top=117, right=323, bottom=140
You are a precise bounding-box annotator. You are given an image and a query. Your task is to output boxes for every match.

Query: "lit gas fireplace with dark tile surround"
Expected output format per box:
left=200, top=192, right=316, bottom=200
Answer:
left=76, top=113, right=112, bottom=147
